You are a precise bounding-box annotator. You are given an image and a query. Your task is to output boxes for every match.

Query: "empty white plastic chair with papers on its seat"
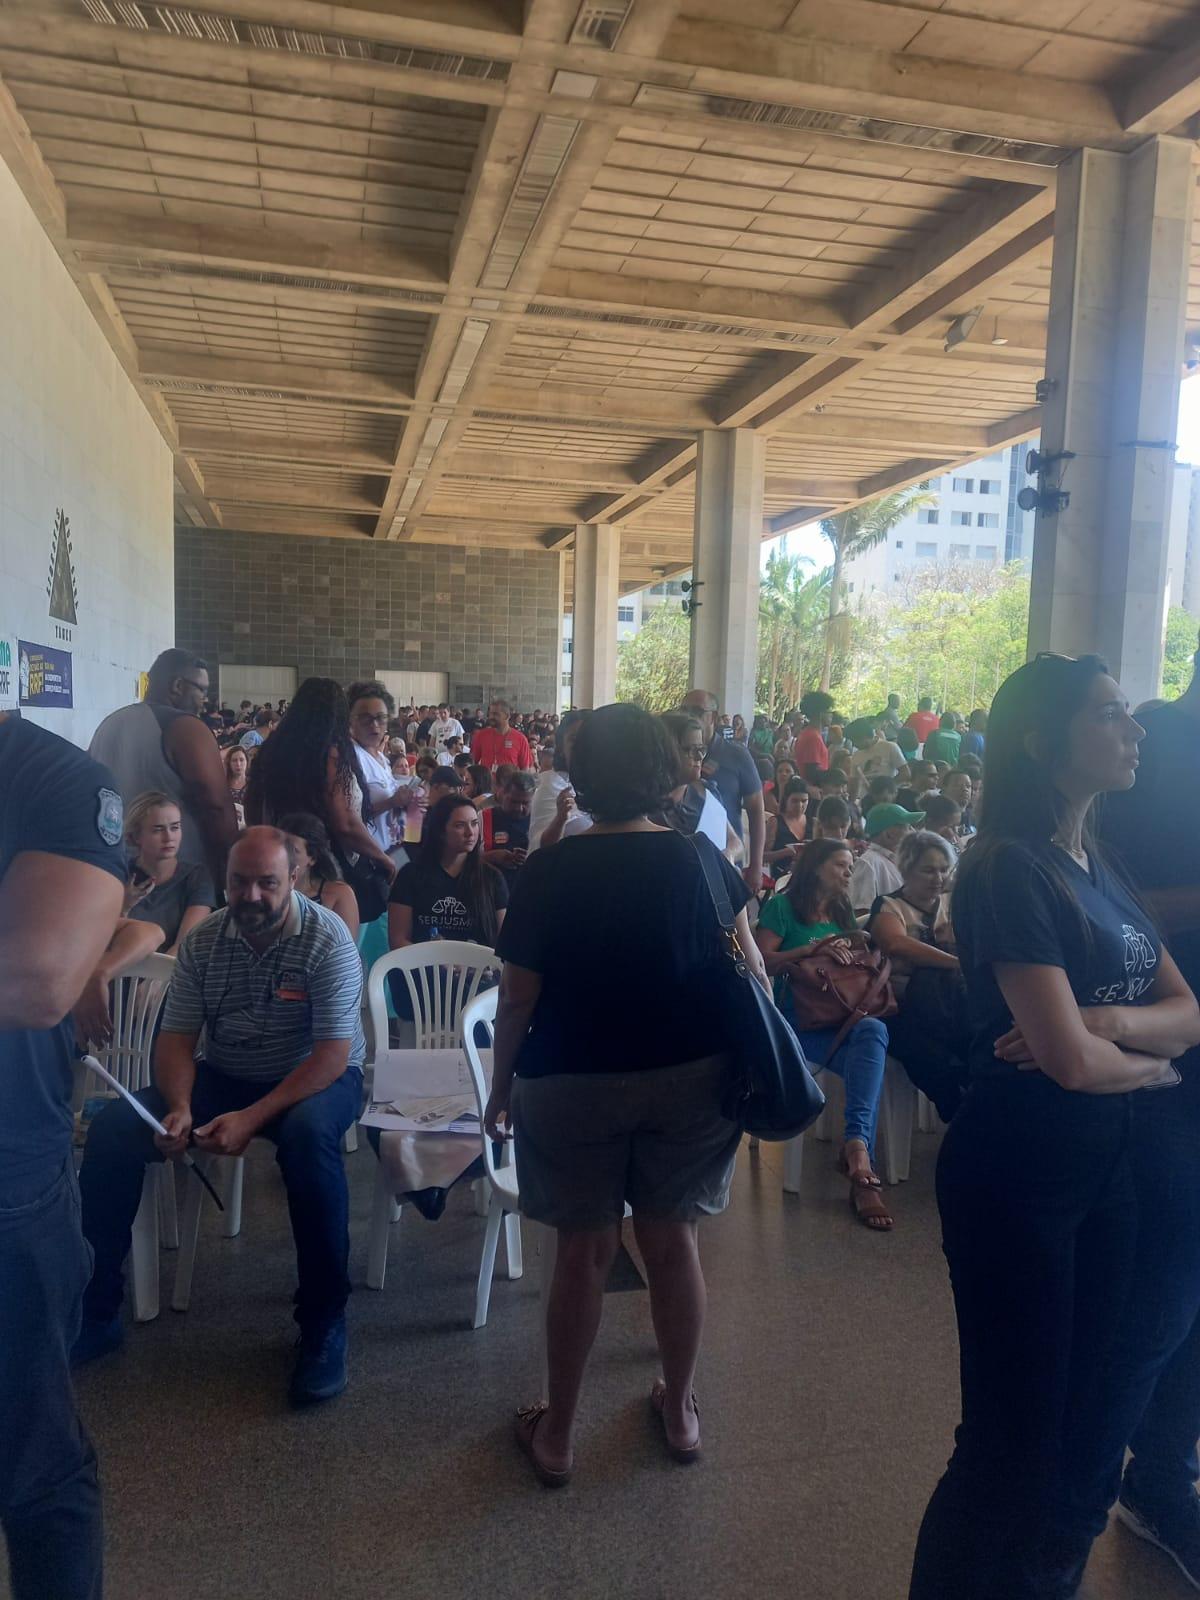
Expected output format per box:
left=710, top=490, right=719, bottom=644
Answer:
left=366, top=939, right=499, bottom=1290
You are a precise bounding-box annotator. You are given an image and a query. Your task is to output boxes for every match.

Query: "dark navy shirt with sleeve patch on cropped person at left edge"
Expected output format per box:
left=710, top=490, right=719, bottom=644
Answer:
left=0, top=718, right=125, bottom=1190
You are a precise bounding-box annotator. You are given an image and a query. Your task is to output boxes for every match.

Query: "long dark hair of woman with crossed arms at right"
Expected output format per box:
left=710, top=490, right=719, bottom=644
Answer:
left=955, top=654, right=1109, bottom=936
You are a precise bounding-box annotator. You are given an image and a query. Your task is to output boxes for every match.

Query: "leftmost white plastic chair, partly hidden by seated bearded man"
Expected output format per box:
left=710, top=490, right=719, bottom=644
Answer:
left=80, top=955, right=179, bottom=1322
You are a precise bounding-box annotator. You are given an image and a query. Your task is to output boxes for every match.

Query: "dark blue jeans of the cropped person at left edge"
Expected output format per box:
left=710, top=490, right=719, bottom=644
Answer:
left=0, top=1160, right=104, bottom=1600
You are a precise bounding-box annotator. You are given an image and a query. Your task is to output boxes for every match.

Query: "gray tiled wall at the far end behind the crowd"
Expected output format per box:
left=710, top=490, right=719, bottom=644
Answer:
left=174, top=528, right=562, bottom=709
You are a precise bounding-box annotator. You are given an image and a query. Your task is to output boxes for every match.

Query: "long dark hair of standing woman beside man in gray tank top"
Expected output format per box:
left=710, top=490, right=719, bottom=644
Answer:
left=246, top=678, right=358, bottom=827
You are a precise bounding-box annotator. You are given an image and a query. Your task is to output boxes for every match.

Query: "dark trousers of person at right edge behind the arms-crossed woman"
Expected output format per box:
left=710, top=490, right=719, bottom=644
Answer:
left=1070, top=1050, right=1200, bottom=1538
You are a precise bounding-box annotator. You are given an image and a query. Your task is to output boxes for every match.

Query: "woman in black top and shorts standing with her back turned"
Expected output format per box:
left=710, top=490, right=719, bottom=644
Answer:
left=485, top=706, right=765, bottom=1485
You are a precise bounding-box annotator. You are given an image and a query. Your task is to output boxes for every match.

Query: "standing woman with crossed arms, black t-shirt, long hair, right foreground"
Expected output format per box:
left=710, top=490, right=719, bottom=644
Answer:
left=910, top=656, right=1200, bottom=1600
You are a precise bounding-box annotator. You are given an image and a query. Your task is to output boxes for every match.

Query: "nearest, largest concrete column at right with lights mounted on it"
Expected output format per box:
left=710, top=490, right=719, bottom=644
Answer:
left=1029, top=138, right=1195, bottom=704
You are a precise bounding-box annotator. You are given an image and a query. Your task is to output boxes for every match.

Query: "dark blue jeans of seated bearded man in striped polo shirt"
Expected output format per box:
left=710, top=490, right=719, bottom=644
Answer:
left=80, top=1061, right=363, bottom=1328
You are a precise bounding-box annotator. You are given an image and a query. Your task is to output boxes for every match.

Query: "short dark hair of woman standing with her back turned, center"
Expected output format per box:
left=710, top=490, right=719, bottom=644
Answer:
left=570, top=706, right=678, bottom=822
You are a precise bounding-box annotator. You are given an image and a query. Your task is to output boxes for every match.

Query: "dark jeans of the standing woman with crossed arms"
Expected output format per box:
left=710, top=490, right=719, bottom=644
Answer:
left=910, top=1077, right=1136, bottom=1600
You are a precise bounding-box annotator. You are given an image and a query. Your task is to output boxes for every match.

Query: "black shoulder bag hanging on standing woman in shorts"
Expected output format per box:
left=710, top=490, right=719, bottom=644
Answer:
left=690, top=835, right=826, bottom=1139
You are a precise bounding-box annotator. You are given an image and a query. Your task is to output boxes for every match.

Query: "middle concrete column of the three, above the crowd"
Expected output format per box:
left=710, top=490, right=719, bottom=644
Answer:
left=690, top=427, right=766, bottom=723
